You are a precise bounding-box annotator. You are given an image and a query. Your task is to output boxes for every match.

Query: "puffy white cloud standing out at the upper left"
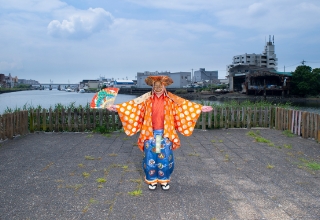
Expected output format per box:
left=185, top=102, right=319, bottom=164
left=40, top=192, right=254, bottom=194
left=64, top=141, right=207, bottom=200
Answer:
left=47, top=8, right=114, bottom=39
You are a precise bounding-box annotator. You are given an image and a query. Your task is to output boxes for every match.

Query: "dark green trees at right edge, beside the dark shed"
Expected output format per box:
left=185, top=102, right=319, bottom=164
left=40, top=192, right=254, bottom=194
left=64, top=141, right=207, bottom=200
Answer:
left=291, top=65, right=320, bottom=96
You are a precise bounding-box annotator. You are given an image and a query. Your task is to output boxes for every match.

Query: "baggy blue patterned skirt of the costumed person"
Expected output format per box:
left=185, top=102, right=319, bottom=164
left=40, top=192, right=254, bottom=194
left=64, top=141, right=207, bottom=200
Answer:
left=142, top=130, right=174, bottom=184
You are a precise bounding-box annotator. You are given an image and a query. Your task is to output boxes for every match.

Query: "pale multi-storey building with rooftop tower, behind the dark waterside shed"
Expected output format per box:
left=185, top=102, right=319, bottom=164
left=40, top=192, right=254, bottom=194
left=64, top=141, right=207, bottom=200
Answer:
left=227, top=36, right=278, bottom=91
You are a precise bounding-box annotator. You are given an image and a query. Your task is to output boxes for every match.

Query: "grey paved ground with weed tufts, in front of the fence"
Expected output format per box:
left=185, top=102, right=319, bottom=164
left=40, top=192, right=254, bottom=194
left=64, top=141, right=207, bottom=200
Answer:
left=0, top=129, right=320, bottom=220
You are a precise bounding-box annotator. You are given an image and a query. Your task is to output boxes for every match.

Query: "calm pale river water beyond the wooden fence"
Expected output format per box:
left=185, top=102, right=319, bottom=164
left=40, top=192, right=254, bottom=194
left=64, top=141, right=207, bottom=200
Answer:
left=0, top=90, right=320, bottom=114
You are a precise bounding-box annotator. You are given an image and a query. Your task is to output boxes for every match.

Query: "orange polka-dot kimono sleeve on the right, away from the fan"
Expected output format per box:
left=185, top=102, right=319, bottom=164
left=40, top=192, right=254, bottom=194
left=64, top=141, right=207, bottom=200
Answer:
left=174, top=100, right=202, bottom=136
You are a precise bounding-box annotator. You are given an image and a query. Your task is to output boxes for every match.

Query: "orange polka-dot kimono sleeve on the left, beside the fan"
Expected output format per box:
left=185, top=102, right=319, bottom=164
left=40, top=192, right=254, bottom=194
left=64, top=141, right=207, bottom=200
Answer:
left=117, top=101, right=145, bottom=136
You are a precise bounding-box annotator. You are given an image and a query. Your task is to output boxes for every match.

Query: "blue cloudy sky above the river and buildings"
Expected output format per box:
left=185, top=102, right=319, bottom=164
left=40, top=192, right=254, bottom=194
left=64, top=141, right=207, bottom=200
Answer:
left=0, top=0, right=320, bottom=83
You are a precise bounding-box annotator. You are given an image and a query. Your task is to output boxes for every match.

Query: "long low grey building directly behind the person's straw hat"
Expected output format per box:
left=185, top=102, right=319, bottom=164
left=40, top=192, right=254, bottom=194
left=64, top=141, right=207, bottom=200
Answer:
left=137, top=71, right=191, bottom=88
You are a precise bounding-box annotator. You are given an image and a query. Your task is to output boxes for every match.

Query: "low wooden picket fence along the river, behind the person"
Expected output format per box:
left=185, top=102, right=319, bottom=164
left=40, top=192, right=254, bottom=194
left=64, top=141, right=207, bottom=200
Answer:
left=0, top=106, right=320, bottom=141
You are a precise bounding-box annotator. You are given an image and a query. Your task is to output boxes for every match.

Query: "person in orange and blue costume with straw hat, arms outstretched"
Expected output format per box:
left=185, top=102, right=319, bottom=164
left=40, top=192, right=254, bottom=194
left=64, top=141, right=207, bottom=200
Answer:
left=109, top=75, right=212, bottom=190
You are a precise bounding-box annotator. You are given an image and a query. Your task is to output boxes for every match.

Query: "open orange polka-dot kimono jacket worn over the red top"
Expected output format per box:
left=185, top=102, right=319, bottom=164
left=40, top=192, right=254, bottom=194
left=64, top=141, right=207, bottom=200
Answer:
left=117, top=92, right=202, bottom=151
